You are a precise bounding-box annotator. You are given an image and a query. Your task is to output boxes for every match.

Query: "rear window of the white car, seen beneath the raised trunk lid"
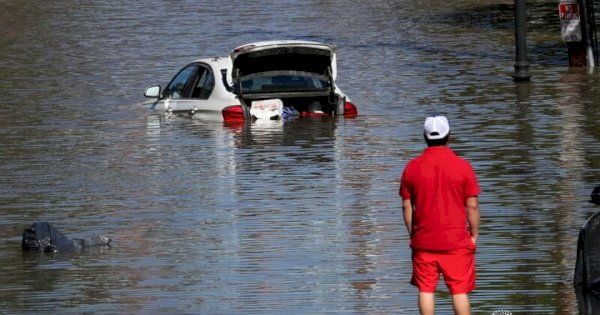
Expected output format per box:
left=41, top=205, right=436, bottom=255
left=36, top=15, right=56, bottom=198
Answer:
left=241, top=73, right=329, bottom=94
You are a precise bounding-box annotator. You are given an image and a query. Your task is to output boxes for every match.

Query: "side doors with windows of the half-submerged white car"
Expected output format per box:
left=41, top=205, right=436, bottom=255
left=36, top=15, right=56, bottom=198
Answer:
left=160, top=63, right=215, bottom=114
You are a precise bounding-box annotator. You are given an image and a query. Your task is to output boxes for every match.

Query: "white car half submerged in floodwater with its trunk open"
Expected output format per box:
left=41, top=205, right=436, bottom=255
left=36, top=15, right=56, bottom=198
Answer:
left=144, top=40, right=358, bottom=122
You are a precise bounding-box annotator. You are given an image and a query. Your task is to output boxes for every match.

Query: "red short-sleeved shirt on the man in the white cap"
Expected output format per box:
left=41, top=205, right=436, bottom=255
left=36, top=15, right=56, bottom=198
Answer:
left=400, top=146, right=480, bottom=250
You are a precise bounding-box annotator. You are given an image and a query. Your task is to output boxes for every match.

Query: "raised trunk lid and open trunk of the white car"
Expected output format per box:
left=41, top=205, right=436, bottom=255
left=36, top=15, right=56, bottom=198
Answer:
left=230, top=41, right=344, bottom=115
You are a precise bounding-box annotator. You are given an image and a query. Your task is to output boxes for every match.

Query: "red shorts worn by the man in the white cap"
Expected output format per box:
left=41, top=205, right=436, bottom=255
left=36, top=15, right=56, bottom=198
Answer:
left=410, top=245, right=475, bottom=295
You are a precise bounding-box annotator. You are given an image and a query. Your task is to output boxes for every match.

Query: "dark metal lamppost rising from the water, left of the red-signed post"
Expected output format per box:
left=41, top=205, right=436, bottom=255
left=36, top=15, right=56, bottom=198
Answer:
left=513, top=0, right=531, bottom=81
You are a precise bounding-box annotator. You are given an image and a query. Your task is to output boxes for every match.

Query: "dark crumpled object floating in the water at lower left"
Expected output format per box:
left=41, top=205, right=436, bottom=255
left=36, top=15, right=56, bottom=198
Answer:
left=22, top=222, right=112, bottom=252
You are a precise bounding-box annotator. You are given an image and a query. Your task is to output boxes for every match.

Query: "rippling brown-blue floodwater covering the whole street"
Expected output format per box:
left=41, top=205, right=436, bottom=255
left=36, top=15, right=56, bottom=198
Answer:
left=0, top=0, right=600, bottom=314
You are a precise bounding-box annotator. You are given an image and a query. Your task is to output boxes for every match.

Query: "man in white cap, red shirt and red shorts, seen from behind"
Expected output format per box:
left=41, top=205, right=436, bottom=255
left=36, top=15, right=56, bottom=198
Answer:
left=400, top=115, right=480, bottom=314
